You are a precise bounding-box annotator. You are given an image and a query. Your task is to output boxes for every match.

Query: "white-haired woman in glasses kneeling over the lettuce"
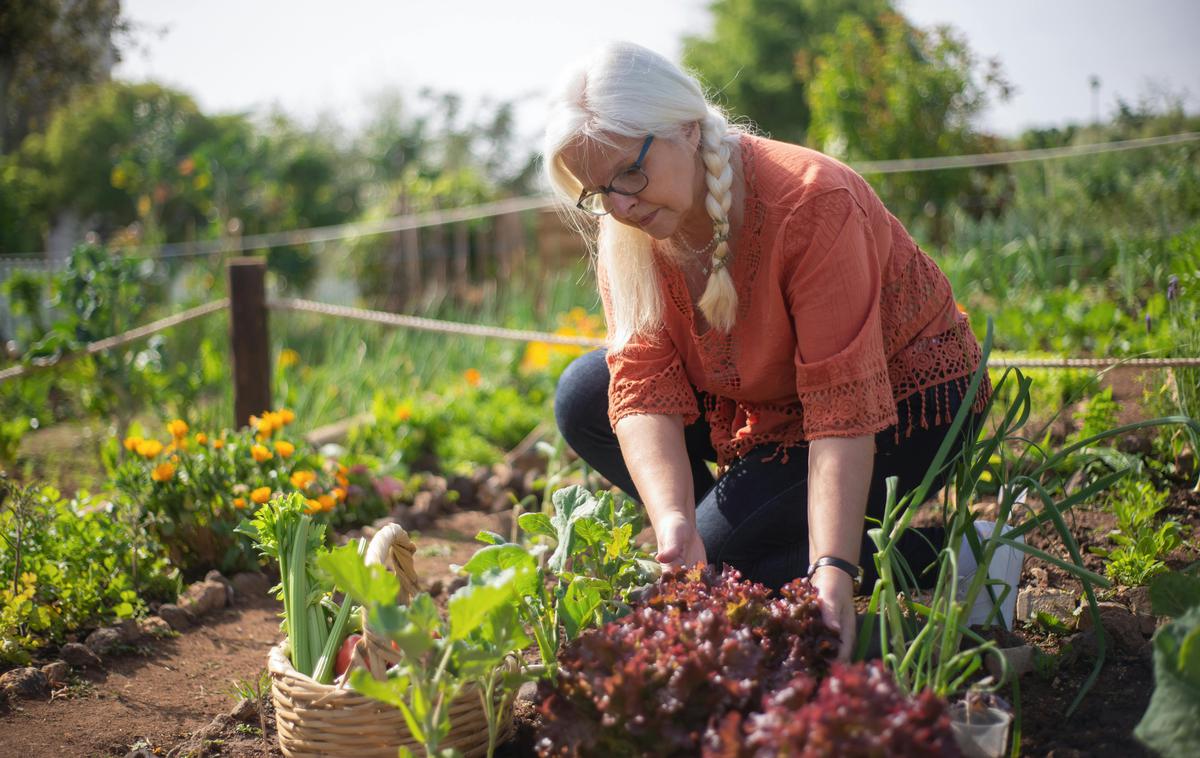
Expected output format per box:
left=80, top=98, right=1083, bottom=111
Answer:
left=544, top=43, right=990, bottom=656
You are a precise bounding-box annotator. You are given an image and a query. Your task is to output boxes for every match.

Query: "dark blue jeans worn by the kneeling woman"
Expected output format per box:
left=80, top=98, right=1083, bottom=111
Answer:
left=554, top=349, right=978, bottom=590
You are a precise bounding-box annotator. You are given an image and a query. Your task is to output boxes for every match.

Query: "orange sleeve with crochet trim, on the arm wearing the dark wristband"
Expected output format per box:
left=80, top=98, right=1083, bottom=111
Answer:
left=781, top=190, right=896, bottom=440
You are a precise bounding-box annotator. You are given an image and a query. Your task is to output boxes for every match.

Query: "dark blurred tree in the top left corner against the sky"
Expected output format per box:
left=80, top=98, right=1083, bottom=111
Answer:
left=0, top=0, right=128, bottom=155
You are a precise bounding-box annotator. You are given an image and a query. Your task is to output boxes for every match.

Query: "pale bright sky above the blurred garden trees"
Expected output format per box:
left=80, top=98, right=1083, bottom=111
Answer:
left=114, top=0, right=1200, bottom=145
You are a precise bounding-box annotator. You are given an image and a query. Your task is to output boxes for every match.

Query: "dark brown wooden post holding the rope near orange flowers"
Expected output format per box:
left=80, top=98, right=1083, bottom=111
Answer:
left=229, top=258, right=271, bottom=428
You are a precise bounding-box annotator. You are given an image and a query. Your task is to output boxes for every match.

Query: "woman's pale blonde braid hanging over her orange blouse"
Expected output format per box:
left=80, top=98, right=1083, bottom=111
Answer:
left=698, top=110, right=738, bottom=332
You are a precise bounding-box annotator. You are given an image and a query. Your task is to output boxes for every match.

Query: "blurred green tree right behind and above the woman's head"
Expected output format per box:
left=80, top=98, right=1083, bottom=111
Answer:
left=683, top=0, right=892, bottom=143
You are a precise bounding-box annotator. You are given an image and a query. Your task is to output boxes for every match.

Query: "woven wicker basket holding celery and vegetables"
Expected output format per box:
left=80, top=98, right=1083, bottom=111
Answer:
left=268, top=524, right=517, bottom=758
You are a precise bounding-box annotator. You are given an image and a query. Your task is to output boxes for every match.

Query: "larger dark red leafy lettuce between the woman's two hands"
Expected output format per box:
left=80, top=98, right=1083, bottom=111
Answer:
left=538, top=567, right=838, bottom=756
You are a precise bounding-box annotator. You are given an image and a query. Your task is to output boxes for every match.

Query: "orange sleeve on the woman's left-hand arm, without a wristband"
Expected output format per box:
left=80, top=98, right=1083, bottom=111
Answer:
left=596, top=259, right=700, bottom=429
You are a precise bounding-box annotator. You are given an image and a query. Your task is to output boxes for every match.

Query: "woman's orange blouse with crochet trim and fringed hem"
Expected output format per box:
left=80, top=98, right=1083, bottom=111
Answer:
left=596, top=136, right=991, bottom=471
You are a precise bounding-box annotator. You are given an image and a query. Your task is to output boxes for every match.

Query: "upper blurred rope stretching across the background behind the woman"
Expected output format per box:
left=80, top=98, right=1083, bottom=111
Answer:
left=7, top=132, right=1200, bottom=259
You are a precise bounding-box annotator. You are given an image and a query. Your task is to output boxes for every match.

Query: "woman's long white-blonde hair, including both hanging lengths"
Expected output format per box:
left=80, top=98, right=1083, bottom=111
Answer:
left=542, top=42, right=742, bottom=350
